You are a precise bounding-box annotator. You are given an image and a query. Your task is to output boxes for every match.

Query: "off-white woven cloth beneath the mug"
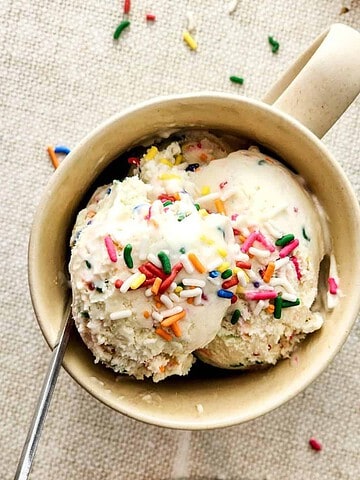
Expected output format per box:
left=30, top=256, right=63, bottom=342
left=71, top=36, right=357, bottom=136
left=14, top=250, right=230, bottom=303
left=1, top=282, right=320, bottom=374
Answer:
left=0, top=0, right=360, bottom=480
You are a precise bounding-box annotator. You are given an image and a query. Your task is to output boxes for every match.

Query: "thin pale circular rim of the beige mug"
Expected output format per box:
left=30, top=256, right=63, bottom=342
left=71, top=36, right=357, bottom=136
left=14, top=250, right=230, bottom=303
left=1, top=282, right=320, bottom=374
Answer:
left=28, top=91, right=360, bottom=430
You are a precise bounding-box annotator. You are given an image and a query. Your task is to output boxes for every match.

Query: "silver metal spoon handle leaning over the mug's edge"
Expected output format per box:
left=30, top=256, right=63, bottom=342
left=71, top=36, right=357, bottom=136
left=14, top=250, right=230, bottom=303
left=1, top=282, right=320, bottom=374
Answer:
left=14, top=302, right=73, bottom=480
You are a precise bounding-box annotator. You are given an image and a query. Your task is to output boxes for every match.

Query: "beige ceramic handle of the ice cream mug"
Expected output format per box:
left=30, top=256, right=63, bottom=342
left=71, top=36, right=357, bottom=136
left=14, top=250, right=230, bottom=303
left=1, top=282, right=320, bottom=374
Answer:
left=262, top=23, right=360, bottom=138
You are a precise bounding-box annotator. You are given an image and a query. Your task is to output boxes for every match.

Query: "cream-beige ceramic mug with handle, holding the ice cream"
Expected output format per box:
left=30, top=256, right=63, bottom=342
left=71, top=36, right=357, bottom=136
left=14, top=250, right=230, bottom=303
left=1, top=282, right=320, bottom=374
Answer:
left=29, top=24, right=360, bottom=429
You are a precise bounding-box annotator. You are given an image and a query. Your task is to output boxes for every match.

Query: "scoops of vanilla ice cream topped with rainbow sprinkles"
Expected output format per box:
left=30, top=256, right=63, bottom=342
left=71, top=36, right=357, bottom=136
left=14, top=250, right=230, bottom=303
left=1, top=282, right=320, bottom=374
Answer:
left=69, top=134, right=329, bottom=381
